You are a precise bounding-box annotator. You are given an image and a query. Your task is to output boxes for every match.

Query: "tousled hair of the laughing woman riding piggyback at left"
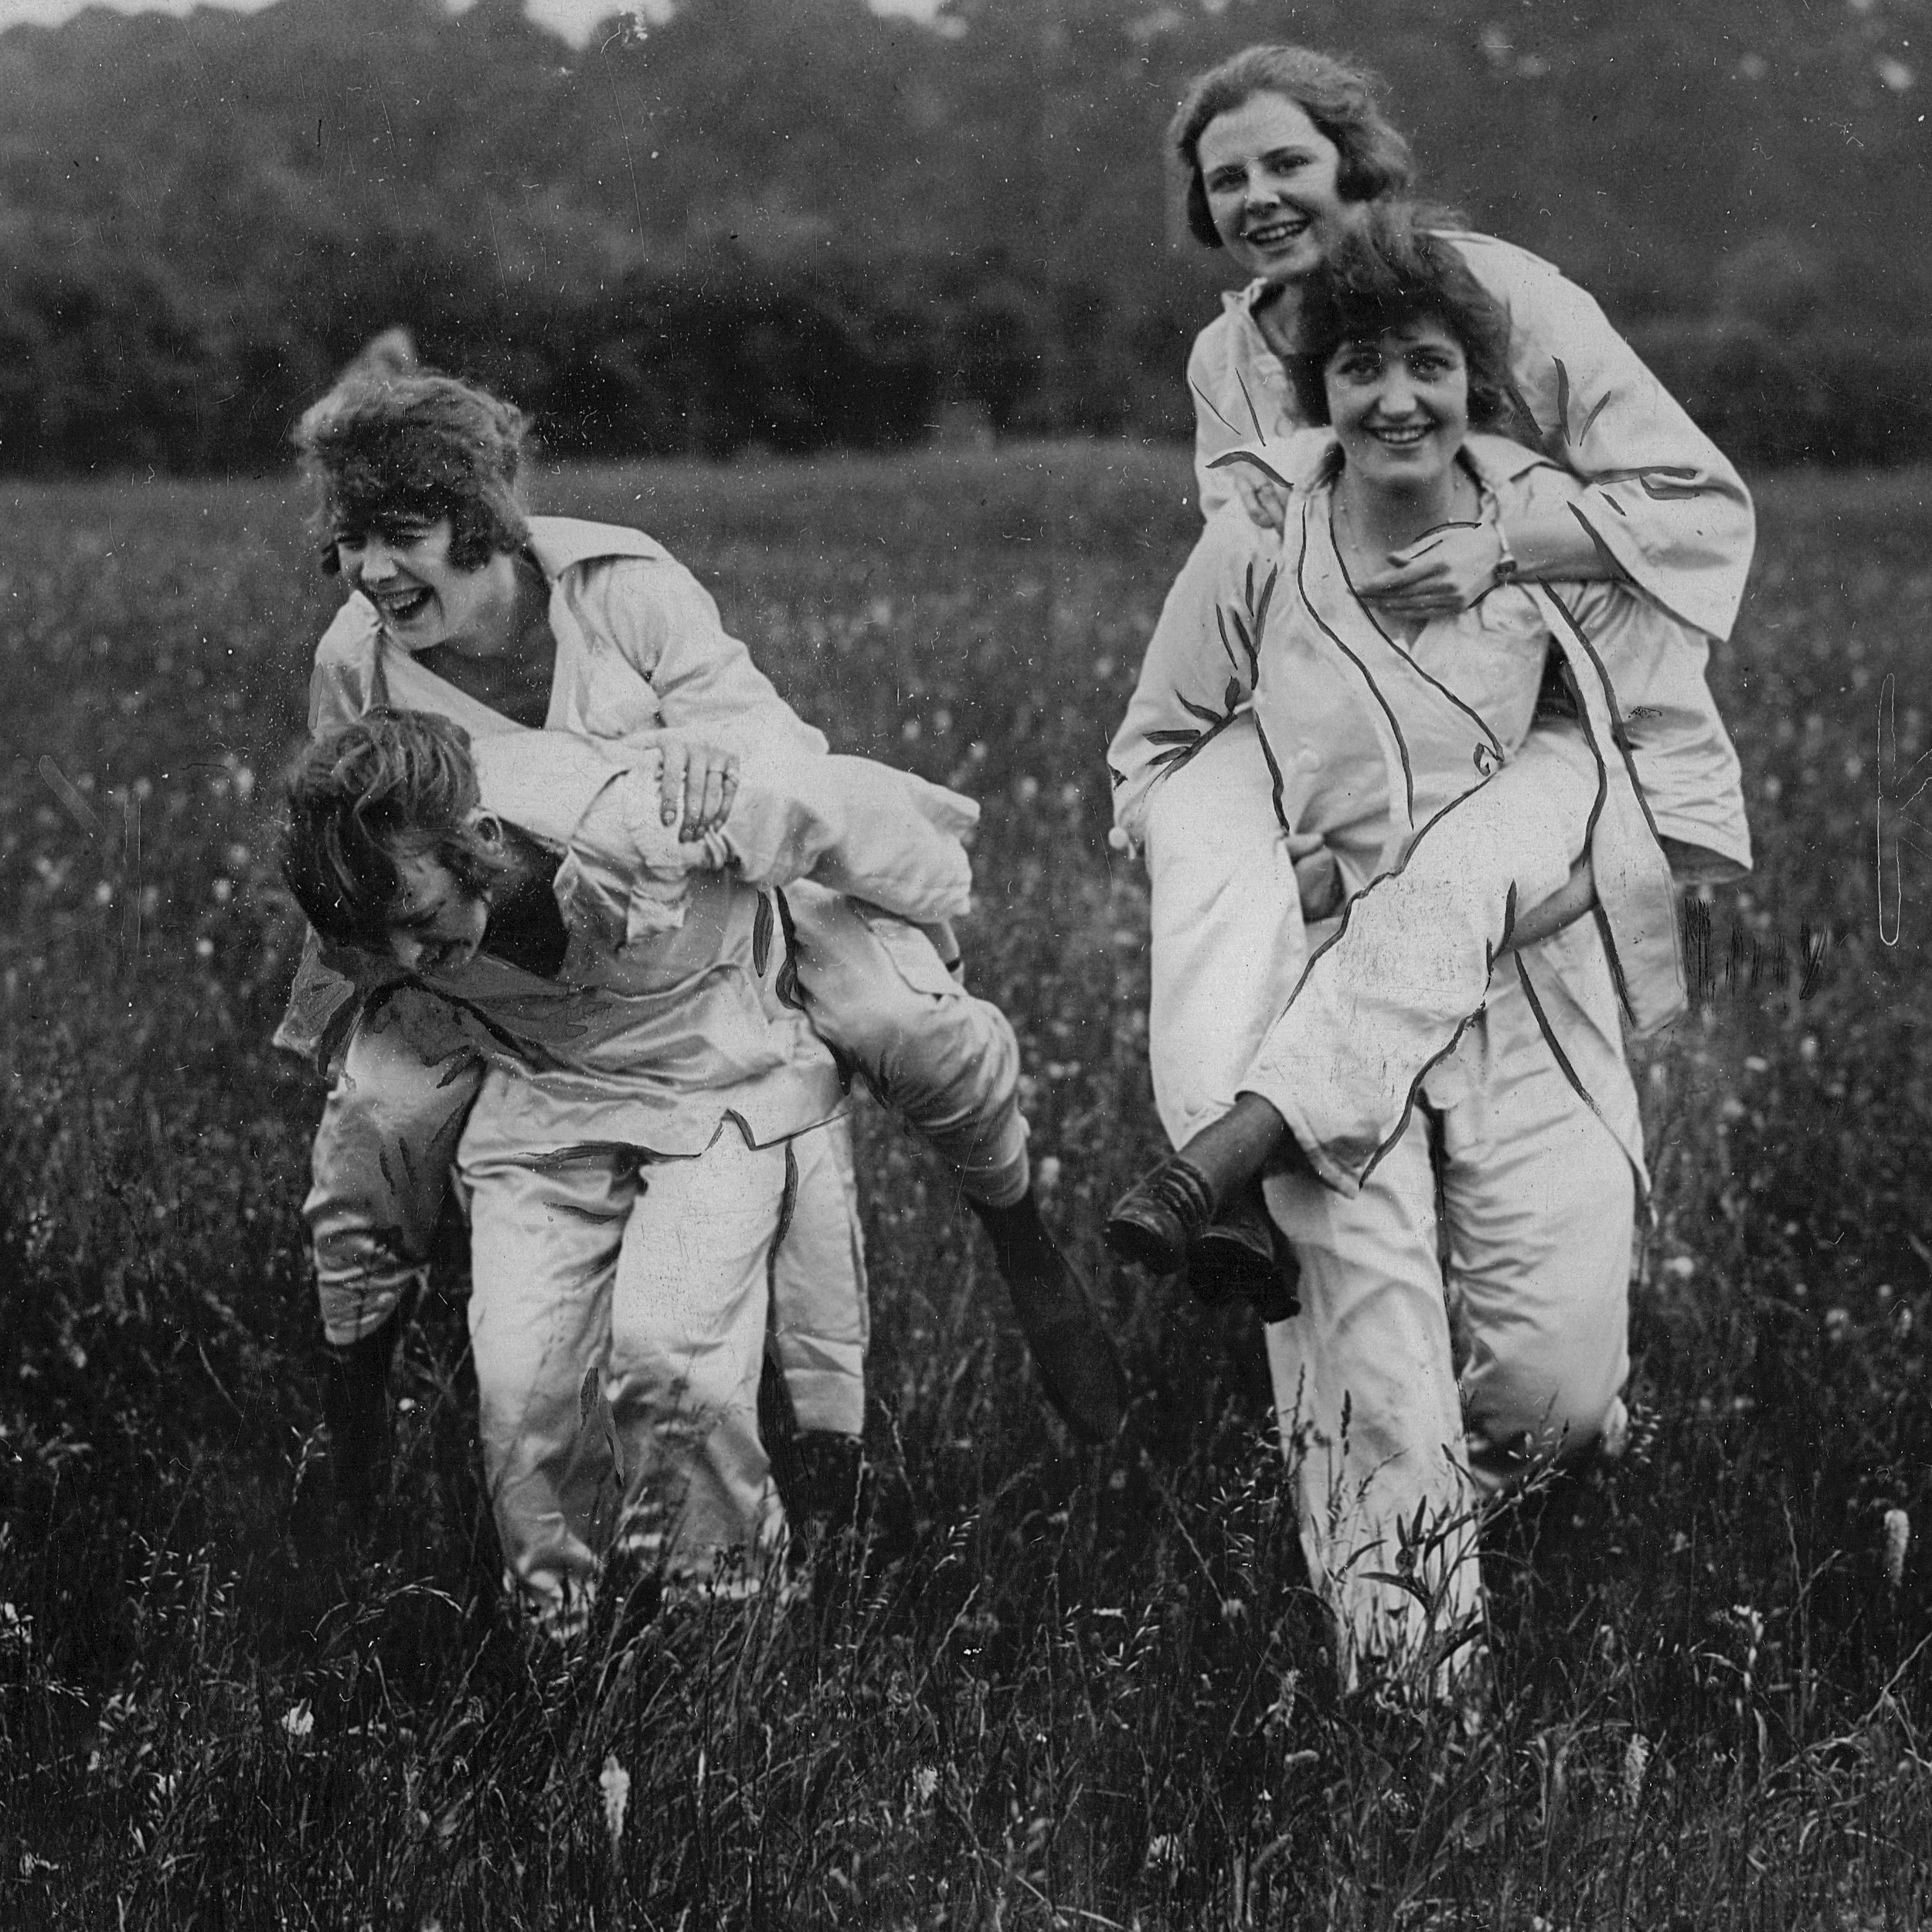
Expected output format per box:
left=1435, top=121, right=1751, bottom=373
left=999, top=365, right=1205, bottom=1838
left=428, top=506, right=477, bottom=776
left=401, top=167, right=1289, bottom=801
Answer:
left=296, top=371, right=529, bottom=572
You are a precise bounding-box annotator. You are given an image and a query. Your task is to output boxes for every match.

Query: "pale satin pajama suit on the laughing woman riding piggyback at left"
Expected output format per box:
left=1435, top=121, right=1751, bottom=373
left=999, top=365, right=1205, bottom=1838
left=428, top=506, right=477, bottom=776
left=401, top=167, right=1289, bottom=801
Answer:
left=277, top=518, right=1028, bottom=1436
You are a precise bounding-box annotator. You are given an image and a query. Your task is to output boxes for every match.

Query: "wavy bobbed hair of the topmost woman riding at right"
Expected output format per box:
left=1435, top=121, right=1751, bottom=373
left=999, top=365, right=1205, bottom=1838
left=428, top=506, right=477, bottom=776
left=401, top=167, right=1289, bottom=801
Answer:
left=1167, top=46, right=1417, bottom=247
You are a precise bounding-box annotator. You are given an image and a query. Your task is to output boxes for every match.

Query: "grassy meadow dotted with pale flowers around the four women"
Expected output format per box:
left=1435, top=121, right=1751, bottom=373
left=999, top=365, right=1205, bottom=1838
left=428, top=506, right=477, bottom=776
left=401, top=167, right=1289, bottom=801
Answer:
left=0, top=447, right=1932, bottom=1932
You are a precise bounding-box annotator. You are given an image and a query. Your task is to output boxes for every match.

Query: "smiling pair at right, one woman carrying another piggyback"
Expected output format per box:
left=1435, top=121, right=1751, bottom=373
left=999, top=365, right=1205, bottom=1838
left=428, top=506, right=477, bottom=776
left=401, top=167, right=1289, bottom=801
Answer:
left=1111, top=49, right=1750, bottom=1675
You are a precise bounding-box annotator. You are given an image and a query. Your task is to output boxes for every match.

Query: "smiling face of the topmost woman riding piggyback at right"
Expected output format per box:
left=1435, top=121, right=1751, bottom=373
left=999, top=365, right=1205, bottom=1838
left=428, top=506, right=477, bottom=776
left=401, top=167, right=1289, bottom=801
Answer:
left=1194, top=95, right=1349, bottom=282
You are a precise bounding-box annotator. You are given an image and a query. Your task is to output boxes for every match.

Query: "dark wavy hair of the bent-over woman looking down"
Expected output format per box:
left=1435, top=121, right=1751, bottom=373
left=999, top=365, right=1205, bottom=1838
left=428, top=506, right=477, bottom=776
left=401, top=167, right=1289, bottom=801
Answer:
left=281, top=711, right=509, bottom=953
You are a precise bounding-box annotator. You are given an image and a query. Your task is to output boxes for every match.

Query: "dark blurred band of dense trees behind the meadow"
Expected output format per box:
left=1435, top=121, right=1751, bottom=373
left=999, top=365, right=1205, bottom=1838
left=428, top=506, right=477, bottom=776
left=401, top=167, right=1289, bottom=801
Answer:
left=0, top=0, right=1932, bottom=471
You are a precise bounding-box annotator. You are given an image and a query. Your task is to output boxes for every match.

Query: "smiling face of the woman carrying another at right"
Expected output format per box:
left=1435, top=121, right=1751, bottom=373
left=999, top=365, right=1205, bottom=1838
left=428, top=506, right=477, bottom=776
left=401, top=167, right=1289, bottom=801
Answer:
left=1321, top=317, right=1468, bottom=491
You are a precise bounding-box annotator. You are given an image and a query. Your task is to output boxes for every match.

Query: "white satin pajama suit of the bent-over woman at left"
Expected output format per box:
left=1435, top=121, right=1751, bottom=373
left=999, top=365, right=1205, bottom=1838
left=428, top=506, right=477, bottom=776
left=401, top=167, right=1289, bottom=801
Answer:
left=372, top=733, right=976, bottom=1627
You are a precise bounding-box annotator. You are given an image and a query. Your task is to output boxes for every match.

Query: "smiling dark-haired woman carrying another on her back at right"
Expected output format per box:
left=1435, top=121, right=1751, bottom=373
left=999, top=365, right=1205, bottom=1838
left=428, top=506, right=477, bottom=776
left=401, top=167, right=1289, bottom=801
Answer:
left=1109, top=203, right=1749, bottom=1675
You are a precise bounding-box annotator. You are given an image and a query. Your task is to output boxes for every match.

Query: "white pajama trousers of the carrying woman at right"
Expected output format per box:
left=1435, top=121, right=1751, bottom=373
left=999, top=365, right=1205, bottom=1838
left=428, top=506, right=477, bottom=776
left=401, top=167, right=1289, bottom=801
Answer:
left=1266, top=968, right=1634, bottom=1683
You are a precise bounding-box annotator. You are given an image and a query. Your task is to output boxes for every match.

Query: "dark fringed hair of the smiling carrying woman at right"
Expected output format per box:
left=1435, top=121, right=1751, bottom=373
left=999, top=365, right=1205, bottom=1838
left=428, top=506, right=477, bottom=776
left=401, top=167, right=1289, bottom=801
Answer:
left=1289, top=201, right=1519, bottom=431
